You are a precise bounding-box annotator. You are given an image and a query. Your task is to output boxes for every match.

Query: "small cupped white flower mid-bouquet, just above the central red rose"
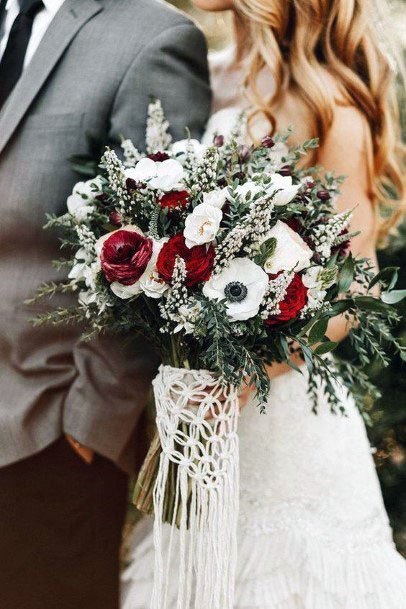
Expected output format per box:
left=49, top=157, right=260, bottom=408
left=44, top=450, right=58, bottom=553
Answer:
left=183, top=203, right=223, bottom=248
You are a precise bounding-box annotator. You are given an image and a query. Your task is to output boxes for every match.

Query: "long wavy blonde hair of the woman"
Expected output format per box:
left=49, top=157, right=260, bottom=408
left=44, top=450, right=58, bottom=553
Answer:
left=234, top=0, right=406, bottom=241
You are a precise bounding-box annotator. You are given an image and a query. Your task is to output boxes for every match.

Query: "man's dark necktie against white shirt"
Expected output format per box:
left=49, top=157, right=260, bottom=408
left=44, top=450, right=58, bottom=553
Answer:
left=0, top=0, right=44, bottom=108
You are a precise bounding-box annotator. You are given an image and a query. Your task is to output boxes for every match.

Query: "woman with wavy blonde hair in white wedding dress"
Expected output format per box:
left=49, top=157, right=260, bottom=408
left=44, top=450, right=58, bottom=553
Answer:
left=122, top=0, right=406, bottom=609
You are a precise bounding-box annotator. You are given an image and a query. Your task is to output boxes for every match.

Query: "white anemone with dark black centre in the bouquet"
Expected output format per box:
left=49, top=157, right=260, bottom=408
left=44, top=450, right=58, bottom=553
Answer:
left=203, top=258, right=268, bottom=321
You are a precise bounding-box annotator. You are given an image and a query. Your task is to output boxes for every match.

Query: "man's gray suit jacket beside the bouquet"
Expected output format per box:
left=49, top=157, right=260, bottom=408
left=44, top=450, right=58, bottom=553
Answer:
left=0, top=0, right=210, bottom=470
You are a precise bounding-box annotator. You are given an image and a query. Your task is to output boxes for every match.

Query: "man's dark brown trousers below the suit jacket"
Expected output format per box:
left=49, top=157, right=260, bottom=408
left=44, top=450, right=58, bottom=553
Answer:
left=0, top=438, right=127, bottom=609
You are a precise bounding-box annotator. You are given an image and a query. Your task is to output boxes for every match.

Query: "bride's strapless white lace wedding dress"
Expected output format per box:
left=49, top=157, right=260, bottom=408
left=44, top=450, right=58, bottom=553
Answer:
left=122, top=47, right=406, bottom=609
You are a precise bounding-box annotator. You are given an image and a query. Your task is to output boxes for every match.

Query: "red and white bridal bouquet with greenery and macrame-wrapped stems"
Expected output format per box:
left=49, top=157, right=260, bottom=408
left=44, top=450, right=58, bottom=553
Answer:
left=33, top=101, right=404, bottom=609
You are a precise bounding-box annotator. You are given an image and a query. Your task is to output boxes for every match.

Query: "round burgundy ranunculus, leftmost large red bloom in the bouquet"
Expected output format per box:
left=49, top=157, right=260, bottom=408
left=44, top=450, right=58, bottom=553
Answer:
left=100, top=229, right=152, bottom=285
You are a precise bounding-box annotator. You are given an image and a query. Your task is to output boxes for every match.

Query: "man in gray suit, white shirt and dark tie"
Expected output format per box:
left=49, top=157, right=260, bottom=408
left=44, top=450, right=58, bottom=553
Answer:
left=0, top=0, right=210, bottom=609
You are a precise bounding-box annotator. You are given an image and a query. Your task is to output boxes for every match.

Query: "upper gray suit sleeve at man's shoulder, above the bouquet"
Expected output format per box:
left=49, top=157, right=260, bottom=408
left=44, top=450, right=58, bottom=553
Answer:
left=109, top=21, right=211, bottom=150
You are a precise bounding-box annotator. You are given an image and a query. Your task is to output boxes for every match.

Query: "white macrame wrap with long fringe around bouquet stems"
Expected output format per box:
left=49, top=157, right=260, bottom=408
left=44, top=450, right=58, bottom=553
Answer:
left=152, top=366, right=239, bottom=609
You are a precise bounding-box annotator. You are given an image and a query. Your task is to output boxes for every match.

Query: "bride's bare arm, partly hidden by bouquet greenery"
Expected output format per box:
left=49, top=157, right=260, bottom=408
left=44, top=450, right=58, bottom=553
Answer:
left=268, top=106, right=378, bottom=378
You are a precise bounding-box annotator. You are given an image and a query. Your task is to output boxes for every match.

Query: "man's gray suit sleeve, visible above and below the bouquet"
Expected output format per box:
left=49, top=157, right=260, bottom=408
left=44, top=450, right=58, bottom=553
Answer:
left=63, top=22, right=211, bottom=471
